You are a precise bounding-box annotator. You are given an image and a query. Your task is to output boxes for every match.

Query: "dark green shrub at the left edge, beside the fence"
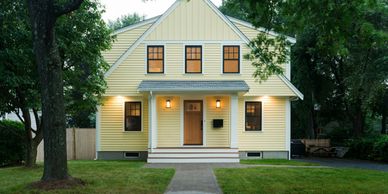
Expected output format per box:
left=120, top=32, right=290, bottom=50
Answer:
left=0, top=120, right=26, bottom=167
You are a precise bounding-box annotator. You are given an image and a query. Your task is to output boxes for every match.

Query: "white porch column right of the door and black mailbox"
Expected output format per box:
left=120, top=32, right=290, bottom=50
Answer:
left=230, top=94, right=238, bottom=148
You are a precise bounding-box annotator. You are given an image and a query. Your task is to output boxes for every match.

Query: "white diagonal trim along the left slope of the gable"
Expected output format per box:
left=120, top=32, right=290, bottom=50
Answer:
left=105, top=1, right=181, bottom=78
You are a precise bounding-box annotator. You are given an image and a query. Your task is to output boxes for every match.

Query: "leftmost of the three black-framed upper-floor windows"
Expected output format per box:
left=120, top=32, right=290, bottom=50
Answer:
left=147, top=46, right=164, bottom=73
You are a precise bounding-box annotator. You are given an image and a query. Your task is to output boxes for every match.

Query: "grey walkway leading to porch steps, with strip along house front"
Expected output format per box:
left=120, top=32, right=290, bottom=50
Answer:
left=144, top=163, right=330, bottom=194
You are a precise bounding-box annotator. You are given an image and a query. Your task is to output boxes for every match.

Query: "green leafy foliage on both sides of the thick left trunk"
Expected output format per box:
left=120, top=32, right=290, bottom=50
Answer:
left=0, top=0, right=112, bottom=166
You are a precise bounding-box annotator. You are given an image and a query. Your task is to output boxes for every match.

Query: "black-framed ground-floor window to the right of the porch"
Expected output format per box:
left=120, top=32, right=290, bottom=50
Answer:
left=245, top=102, right=262, bottom=131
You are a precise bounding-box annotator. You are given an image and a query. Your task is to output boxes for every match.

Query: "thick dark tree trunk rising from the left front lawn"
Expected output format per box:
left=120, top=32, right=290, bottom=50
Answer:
left=29, top=0, right=69, bottom=181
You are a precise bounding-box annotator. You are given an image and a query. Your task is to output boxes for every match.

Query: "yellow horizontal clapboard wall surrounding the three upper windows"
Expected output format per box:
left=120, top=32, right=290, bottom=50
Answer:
left=105, top=43, right=295, bottom=96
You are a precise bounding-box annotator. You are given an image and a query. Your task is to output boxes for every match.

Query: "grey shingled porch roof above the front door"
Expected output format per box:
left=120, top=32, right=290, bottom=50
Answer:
left=138, top=80, right=249, bottom=92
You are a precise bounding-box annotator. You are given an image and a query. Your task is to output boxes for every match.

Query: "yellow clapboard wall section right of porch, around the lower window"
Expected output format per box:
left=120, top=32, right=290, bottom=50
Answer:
left=238, top=96, right=287, bottom=151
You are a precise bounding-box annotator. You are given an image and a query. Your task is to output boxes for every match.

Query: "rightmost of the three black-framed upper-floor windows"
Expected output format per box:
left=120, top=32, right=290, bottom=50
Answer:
left=223, top=46, right=240, bottom=73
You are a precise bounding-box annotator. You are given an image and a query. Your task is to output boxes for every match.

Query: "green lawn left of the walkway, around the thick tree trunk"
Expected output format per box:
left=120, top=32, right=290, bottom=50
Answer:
left=0, top=161, right=174, bottom=193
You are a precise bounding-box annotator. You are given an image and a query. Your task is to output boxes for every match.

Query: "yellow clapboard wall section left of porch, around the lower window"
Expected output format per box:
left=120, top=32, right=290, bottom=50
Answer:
left=99, top=96, right=148, bottom=151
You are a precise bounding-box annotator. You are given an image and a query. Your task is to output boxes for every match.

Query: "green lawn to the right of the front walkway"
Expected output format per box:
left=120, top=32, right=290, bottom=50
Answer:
left=215, top=167, right=388, bottom=194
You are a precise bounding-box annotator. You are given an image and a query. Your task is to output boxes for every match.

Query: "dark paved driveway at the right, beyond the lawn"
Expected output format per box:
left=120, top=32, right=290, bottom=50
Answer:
left=295, top=157, right=388, bottom=172
